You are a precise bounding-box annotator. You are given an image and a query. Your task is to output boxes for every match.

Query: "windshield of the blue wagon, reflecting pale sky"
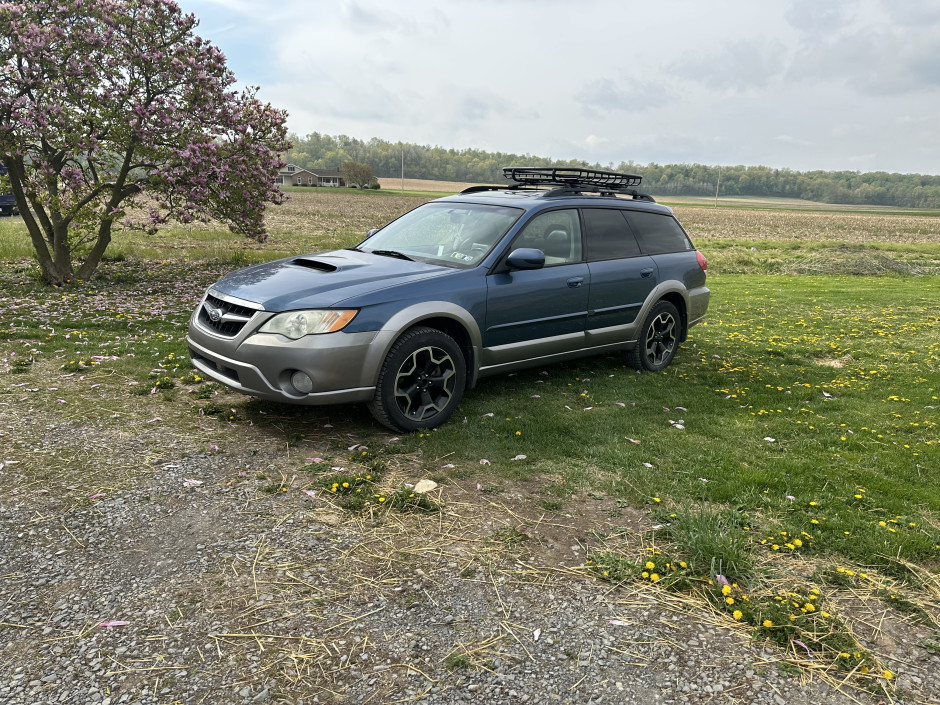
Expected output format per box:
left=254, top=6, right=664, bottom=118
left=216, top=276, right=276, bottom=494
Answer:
left=359, top=202, right=523, bottom=267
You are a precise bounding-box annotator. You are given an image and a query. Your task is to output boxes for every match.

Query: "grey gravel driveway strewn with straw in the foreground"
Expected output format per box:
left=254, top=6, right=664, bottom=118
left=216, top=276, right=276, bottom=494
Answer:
left=0, top=390, right=940, bottom=705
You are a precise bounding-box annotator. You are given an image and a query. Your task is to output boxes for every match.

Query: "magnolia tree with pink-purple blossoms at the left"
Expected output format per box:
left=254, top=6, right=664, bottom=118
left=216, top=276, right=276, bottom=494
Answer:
left=0, top=0, right=290, bottom=284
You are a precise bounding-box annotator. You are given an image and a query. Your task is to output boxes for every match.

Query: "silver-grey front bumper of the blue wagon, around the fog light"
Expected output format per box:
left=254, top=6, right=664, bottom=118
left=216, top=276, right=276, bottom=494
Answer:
left=186, top=321, right=378, bottom=405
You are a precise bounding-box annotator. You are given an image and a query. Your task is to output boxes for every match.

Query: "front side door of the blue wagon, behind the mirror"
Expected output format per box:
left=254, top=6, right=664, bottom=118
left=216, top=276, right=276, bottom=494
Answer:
left=483, top=208, right=590, bottom=365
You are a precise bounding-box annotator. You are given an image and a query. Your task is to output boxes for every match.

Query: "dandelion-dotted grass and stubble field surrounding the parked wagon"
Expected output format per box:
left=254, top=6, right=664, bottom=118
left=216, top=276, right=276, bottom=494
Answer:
left=0, top=189, right=940, bottom=688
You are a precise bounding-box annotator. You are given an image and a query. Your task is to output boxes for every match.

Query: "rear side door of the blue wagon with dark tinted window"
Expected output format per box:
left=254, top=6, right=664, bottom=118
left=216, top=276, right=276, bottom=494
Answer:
left=582, top=208, right=658, bottom=347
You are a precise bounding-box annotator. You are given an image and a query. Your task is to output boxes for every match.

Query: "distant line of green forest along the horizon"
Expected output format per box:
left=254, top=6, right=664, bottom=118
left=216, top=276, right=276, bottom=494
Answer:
left=285, top=132, right=940, bottom=208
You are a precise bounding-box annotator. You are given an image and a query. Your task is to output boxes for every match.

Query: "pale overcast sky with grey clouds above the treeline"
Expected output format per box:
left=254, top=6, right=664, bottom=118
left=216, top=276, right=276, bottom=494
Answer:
left=178, top=0, right=940, bottom=174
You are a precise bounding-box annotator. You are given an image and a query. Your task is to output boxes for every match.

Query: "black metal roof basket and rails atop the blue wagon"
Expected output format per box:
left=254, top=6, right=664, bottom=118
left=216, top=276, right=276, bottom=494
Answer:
left=461, top=166, right=654, bottom=201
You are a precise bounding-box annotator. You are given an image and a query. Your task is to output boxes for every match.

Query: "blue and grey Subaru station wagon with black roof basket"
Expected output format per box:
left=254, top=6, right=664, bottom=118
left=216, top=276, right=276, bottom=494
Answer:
left=187, top=167, right=709, bottom=432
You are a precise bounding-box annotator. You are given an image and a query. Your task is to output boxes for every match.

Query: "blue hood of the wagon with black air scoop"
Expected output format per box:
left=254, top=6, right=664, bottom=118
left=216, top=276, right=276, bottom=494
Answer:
left=211, top=250, right=454, bottom=312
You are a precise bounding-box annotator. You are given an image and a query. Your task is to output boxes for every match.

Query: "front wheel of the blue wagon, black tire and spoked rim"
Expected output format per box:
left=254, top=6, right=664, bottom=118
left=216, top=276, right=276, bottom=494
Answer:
left=369, top=327, right=467, bottom=433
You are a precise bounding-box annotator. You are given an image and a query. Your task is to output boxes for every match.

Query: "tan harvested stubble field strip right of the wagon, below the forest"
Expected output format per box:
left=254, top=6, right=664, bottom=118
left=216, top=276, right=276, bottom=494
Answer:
left=674, top=206, right=940, bottom=243
